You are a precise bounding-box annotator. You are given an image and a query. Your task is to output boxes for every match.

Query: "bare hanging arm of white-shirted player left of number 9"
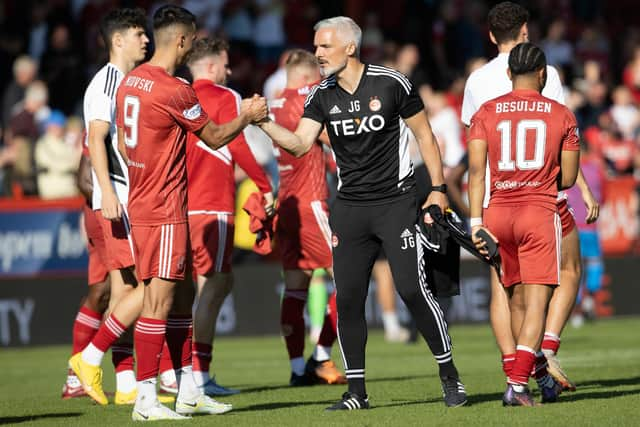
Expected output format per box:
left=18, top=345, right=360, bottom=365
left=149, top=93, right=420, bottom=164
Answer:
left=87, top=120, right=122, bottom=221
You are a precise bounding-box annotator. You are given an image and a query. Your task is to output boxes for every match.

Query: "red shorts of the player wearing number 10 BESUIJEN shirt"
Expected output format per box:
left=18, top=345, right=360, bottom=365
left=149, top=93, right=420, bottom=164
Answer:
left=483, top=205, right=562, bottom=287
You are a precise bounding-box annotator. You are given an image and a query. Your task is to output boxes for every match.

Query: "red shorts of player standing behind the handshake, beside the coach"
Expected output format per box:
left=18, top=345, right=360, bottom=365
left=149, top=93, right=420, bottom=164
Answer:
left=276, top=197, right=333, bottom=270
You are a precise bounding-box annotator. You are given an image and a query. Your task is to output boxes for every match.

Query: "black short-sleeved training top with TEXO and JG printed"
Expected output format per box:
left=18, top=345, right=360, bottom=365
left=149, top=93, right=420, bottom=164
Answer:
left=303, top=64, right=424, bottom=204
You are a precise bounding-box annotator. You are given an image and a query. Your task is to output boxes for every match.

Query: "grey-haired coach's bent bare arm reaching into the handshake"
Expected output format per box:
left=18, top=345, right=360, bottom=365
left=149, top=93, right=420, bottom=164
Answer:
left=258, top=117, right=322, bottom=157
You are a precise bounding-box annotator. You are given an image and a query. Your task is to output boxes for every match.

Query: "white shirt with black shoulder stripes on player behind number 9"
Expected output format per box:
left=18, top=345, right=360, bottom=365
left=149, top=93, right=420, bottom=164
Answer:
left=83, top=63, right=129, bottom=210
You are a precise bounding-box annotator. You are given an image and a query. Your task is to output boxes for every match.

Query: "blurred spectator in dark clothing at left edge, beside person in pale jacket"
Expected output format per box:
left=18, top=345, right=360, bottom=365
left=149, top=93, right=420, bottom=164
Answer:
left=3, top=80, right=50, bottom=195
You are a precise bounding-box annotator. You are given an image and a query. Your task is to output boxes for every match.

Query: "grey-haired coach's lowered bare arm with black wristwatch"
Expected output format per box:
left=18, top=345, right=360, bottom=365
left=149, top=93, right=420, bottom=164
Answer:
left=404, top=109, right=449, bottom=217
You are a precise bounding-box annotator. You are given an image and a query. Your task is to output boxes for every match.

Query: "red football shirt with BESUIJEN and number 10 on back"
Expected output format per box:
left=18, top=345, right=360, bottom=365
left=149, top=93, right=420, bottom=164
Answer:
left=468, top=89, right=580, bottom=209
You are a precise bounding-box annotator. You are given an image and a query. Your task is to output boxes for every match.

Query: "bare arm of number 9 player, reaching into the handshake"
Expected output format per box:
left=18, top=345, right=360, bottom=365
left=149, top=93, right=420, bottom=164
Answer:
left=194, top=96, right=268, bottom=150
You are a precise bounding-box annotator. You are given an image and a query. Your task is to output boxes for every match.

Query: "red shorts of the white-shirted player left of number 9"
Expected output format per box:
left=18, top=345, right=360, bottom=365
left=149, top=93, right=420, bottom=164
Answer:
left=96, top=210, right=135, bottom=271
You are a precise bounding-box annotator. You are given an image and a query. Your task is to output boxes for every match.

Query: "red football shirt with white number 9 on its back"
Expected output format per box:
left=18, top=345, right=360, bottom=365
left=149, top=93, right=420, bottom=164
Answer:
left=116, top=63, right=209, bottom=225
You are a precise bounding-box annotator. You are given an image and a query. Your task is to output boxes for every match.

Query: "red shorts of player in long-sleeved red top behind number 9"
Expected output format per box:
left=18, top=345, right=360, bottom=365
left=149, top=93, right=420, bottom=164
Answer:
left=189, top=213, right=235, bottom=276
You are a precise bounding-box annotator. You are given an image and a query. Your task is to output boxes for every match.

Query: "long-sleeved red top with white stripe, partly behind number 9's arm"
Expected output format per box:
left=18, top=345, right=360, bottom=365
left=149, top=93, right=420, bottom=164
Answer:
left=187, top=80, right=271, bottom=214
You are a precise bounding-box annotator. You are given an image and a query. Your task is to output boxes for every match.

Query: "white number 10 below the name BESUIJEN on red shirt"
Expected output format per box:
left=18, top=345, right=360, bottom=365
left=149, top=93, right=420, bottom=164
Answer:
left=497, top=120, right=547, bottom=171
